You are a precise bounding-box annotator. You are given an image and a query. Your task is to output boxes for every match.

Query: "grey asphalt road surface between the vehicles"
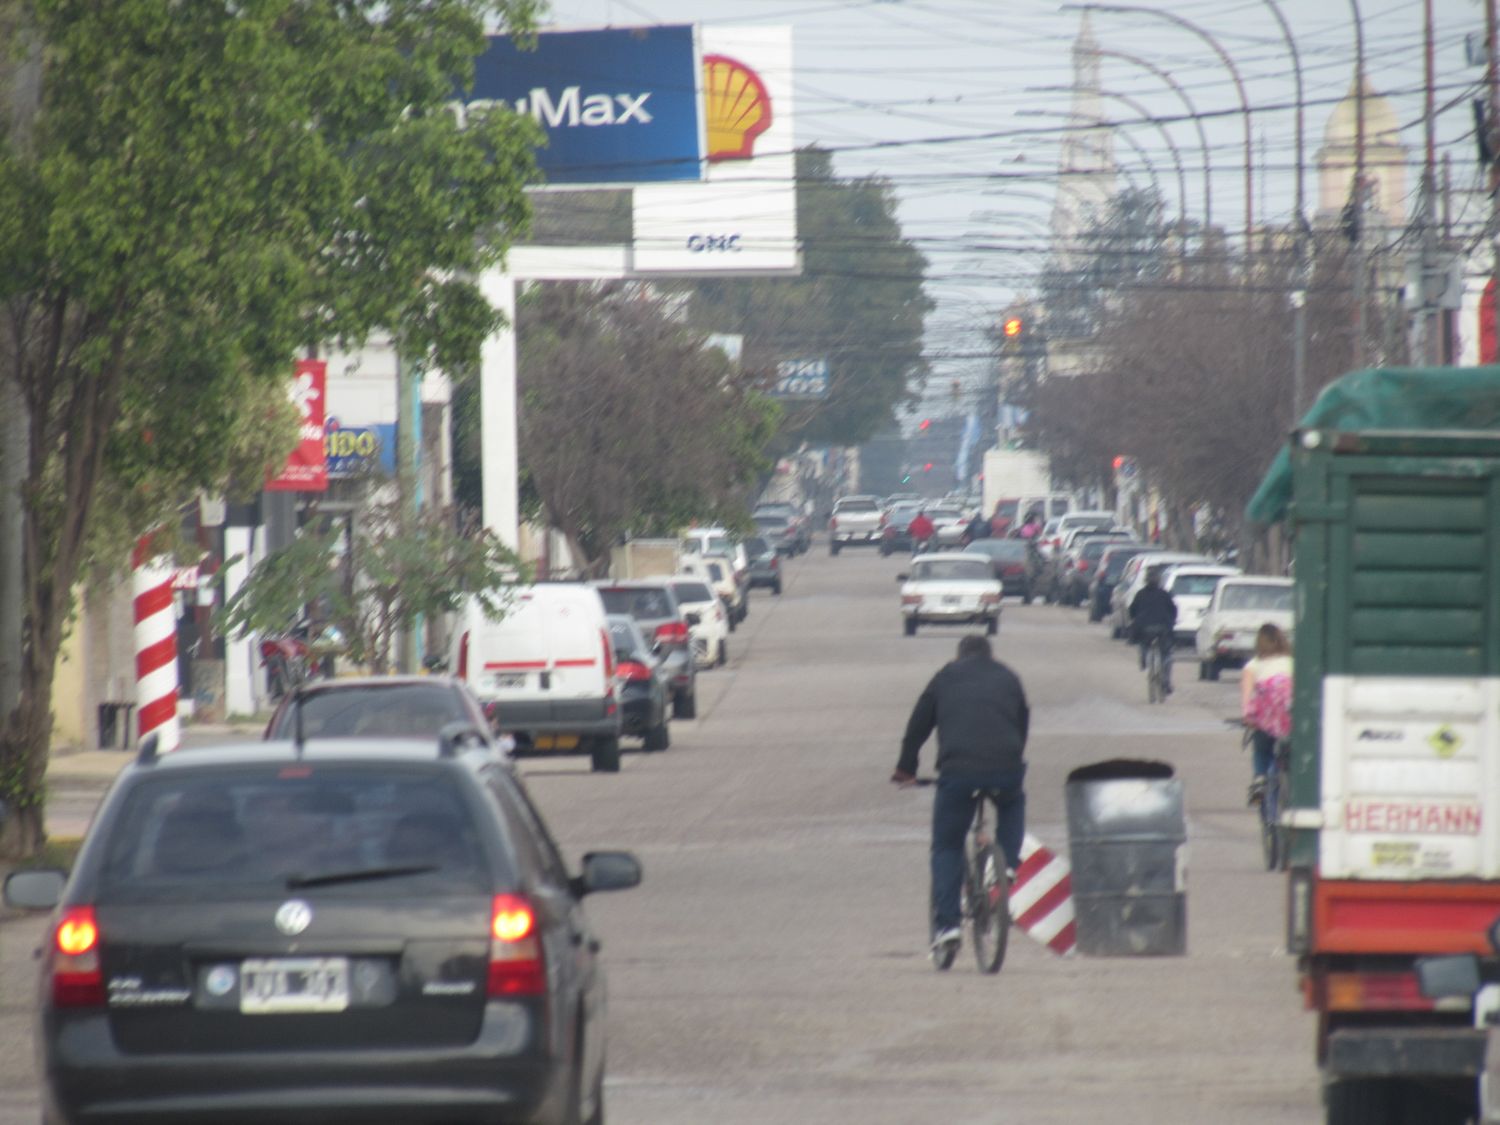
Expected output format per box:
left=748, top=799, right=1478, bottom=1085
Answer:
left=0, top=548, right=1320, bottom=1125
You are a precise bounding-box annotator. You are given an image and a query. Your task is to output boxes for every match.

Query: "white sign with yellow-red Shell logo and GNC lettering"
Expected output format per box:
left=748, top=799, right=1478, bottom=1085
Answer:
left=633, top=26, right=801, bottom=275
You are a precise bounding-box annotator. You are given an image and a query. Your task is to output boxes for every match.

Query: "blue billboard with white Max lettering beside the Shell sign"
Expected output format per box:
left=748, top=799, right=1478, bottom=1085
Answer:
left=465, top=24, right=702, bottom=185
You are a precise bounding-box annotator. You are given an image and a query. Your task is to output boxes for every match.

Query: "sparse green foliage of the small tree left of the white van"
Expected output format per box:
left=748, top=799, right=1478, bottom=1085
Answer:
left=219, top=501, right=525, bottom=672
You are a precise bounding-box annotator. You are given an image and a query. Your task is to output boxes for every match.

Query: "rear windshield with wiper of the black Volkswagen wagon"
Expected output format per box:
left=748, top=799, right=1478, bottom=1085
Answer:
left=99, top=764, right=498, bottom=903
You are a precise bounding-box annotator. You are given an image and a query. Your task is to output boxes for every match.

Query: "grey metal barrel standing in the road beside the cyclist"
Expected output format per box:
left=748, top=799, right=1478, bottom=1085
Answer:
left=1064, top=759, right=1188, bottom=957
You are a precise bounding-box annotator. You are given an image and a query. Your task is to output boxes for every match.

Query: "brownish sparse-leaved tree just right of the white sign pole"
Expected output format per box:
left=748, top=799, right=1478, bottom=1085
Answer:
left=477, top=282, right=780, bottom=573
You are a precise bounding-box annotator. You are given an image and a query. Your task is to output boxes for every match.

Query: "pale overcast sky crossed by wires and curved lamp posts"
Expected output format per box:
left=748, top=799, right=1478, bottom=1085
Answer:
left=549, top=0, right=1484, bottom=423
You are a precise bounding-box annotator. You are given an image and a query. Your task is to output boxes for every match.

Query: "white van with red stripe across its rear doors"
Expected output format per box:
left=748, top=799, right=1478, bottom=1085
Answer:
left=449, top=582, right=620, bottom=773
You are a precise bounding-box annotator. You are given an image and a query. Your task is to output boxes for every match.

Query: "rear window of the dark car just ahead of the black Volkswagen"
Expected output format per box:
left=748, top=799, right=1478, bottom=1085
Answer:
left=266, top=684, right=470, bottom=738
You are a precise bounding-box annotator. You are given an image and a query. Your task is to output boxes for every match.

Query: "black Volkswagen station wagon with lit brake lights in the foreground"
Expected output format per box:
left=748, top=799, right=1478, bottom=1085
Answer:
left=5, top=726, right=641, bottom=1125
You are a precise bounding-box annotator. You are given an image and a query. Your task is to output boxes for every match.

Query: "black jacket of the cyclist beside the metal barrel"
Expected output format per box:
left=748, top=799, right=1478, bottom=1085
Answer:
left=896, top=657, right=1031, bottom=776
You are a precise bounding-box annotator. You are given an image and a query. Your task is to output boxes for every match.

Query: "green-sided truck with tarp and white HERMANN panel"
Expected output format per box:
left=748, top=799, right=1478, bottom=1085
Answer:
left=1248, top=368, right=1500, bottom=1125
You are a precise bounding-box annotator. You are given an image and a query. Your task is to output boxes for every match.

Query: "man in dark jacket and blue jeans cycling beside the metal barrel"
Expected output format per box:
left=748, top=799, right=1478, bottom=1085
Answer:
left=891, top=635, right=1031, bottom=957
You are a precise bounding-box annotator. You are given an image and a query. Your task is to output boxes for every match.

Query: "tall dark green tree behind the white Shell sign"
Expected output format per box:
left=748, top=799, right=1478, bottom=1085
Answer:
left=687, top=149, right=935, bottom=447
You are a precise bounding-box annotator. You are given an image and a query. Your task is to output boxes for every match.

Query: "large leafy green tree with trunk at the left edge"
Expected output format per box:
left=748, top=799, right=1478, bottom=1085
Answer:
left=0, top=0, right=537, bottom=851
